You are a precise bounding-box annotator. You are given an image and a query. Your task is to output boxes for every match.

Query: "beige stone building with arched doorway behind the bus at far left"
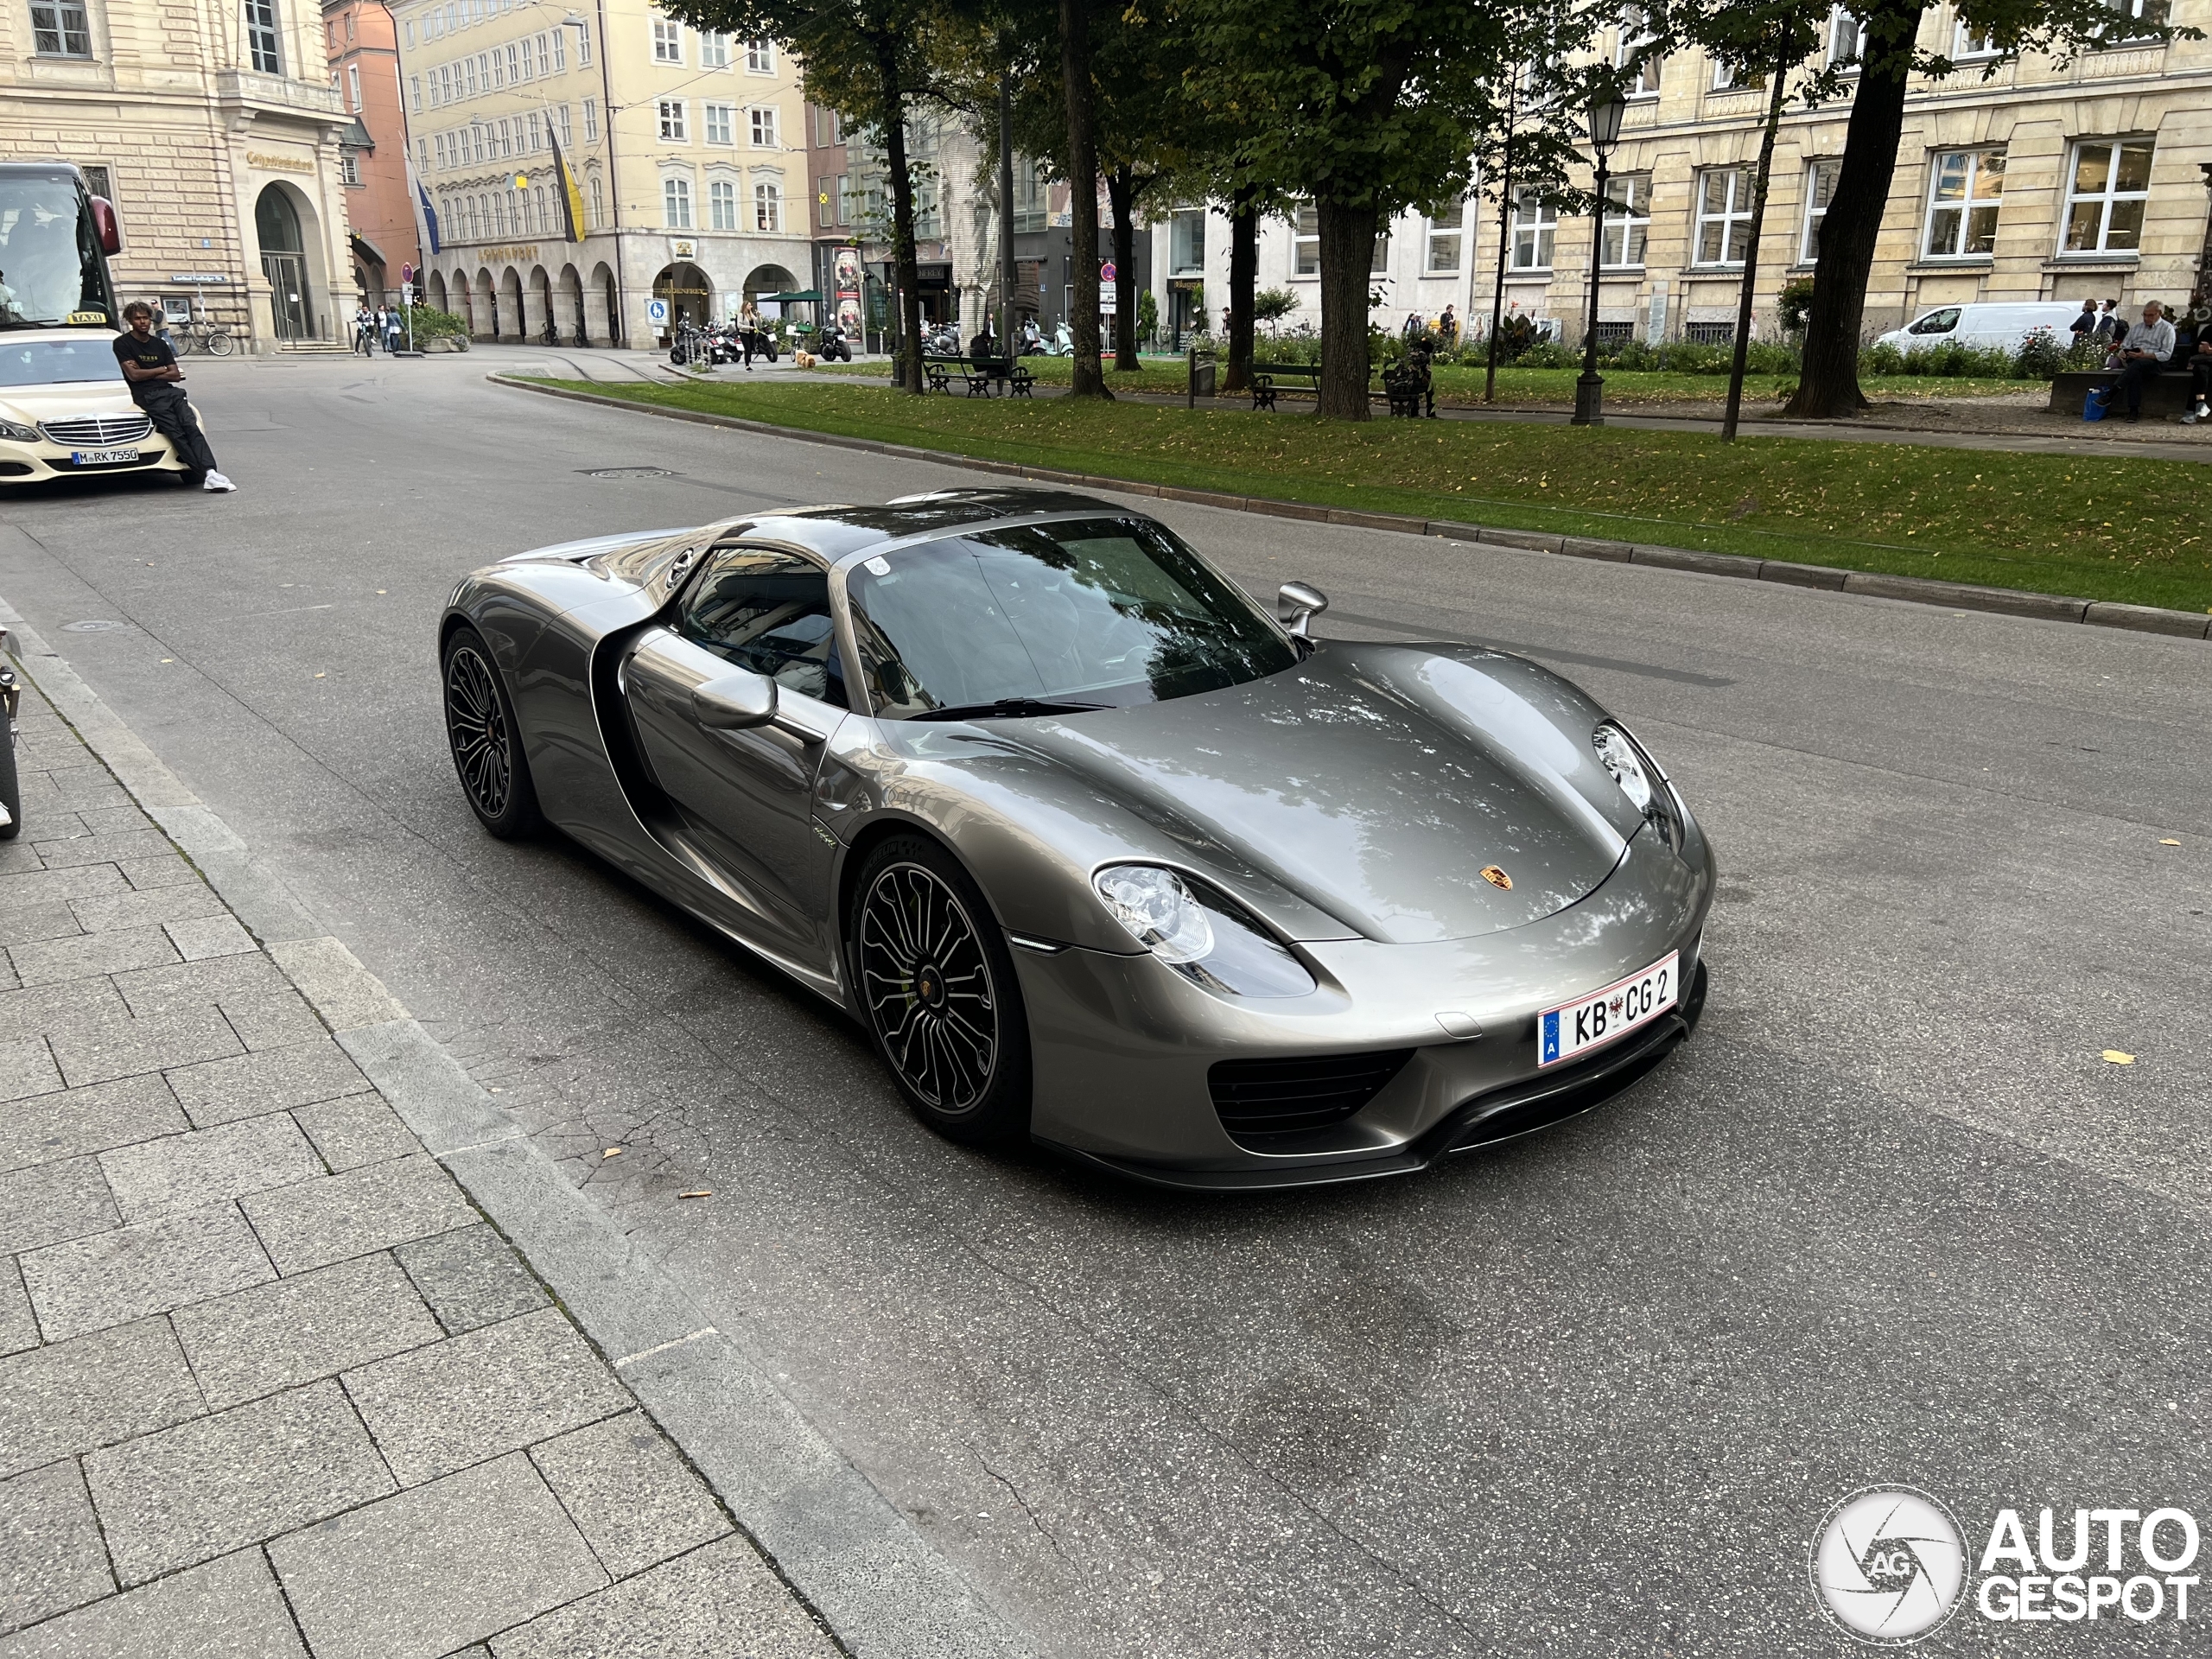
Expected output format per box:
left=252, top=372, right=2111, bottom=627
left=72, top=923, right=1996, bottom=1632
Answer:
left=0, top=0, right=354, bottom=349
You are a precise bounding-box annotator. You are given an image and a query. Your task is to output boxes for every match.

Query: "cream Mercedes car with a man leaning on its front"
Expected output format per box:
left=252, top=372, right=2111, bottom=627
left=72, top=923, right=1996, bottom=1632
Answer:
left=0, top=327, right=186, bottom=485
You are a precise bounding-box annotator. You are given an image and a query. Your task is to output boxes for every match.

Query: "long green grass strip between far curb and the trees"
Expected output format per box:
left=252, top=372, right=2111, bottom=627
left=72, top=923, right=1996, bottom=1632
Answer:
left=526, top=380, right=2212, bottom=613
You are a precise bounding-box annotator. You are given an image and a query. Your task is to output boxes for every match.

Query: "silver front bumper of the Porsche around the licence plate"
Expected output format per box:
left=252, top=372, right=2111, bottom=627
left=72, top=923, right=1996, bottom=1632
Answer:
left=1015, top=834, right=1714, bottom=1190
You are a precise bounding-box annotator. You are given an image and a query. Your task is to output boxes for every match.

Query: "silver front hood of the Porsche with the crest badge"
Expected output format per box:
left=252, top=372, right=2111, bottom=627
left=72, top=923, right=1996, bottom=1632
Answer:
left=991, top=644, right=1639, bottom=944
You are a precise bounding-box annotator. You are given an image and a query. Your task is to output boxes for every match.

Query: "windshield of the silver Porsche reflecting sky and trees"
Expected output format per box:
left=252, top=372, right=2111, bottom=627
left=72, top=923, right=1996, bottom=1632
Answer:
left=845, top=518, right=1299, bottom=719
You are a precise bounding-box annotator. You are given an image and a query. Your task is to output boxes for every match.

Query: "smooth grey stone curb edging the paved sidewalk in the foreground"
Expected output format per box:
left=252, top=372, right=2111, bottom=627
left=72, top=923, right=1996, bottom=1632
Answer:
left=0, top=600, right=1031, bottom=1659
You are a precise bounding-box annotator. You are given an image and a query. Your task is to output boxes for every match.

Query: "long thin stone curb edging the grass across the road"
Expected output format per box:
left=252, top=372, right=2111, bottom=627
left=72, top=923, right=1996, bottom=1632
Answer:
left=485, top=374, right=2212, bottom=639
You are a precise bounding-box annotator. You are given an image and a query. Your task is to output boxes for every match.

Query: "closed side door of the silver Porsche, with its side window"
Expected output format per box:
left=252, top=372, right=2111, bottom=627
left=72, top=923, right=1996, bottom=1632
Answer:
left=621, top=546, right=845, bottom=971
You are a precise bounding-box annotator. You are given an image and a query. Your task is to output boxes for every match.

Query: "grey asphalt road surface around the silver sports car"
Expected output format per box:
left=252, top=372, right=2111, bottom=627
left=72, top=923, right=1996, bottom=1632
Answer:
left=0, top=354, right=2212, bottom=1659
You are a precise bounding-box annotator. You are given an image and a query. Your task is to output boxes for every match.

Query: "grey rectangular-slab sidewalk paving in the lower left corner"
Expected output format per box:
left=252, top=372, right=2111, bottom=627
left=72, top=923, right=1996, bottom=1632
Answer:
left=0, top=672, right=838, bottom=1659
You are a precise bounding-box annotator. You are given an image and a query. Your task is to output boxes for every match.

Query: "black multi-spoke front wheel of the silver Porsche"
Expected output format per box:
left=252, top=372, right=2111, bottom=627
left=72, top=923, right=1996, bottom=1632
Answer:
left=847, top=836, right=1031, bottom=1146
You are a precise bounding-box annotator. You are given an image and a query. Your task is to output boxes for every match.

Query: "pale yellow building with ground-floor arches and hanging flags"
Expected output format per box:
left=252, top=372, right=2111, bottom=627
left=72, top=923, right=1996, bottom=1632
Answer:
left=394, top=0, right=810, bottom=345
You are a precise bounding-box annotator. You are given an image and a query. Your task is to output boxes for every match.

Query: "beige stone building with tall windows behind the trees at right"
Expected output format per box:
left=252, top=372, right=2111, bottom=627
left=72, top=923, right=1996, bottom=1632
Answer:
left=1476, top=0, right=2212, bottom=340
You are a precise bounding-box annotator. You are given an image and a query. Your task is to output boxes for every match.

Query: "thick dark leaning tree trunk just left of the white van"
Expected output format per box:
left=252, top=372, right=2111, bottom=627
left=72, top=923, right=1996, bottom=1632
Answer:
left=1783, top=0, right=1923, bottom=420
